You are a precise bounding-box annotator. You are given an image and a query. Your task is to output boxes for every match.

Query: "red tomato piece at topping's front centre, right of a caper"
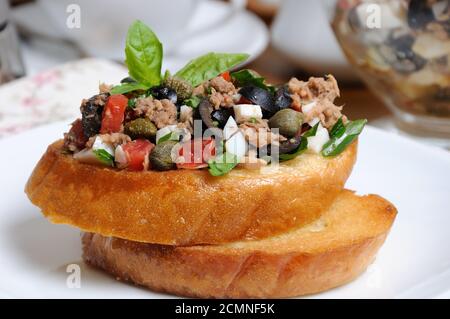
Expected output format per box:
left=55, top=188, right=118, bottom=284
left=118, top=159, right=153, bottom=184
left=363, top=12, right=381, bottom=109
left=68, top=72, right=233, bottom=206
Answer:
left=177, top=139, right=216, bottom=169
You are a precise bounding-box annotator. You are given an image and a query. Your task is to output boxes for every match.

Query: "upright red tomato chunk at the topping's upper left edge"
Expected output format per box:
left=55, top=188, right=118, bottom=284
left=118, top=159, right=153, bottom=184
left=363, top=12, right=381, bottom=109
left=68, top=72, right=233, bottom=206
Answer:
left=100, top=94, right=128, bottom=134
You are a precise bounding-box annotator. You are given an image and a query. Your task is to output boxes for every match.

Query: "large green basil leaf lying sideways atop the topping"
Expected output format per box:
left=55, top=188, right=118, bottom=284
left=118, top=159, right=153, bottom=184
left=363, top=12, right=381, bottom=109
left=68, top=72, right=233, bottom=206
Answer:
left=175, top=52, right=249, bottom=87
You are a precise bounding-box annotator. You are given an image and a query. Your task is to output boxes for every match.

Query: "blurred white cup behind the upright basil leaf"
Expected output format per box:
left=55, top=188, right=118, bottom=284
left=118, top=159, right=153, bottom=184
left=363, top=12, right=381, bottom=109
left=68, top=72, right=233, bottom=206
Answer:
left=38, top=0, right=245, bottom=58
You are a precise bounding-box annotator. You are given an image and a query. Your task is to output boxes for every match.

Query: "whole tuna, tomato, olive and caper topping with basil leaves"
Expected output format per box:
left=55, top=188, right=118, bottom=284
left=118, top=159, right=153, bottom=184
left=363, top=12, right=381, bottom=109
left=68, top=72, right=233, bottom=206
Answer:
left=64, top=21, right=366, bottom=176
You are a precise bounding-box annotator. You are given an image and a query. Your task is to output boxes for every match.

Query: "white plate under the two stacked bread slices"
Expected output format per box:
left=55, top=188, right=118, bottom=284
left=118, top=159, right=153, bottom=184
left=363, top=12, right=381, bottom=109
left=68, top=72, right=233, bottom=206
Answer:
left=0, top=123, right=450, bottom=298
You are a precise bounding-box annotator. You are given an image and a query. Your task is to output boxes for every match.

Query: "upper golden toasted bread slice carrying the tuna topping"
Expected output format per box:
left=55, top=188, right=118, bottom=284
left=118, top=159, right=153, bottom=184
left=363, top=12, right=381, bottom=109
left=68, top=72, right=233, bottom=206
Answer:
left=25, top=141, right=357, bottom=245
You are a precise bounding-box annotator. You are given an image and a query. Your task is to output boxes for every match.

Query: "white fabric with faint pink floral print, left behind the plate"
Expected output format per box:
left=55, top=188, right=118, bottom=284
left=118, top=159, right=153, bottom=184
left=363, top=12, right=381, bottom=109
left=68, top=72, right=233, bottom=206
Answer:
left=0, top=59, right=127, bottom=138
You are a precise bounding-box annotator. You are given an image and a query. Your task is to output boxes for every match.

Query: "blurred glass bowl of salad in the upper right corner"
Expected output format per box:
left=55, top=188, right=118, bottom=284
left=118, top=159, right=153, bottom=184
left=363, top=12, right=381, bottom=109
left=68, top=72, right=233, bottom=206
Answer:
left=323, top=0, right=450, bottom=148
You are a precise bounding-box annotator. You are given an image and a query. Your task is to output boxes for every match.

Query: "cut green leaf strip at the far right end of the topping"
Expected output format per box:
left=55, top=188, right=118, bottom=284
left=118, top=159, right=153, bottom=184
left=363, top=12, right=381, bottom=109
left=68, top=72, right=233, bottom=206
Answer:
left=322, top=119, right=367, bottom=157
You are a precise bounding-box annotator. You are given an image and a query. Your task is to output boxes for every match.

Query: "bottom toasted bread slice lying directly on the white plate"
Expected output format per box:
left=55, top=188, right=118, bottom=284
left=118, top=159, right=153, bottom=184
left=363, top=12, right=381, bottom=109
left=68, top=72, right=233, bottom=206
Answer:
left=82, top=190, right=397, bottom=298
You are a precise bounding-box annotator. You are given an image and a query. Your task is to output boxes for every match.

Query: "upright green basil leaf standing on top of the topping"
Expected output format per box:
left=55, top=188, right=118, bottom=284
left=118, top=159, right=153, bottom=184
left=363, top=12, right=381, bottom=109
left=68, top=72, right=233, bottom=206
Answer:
left=125, top=20, right=163, bottom=87
